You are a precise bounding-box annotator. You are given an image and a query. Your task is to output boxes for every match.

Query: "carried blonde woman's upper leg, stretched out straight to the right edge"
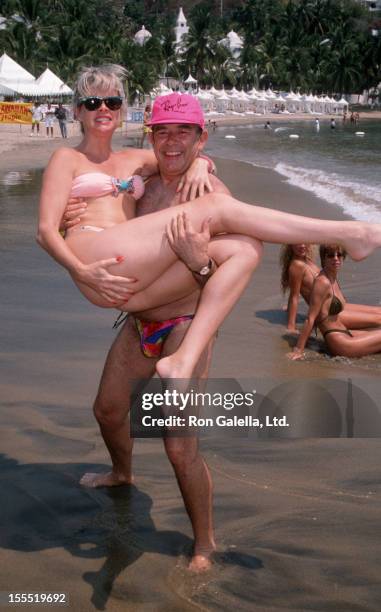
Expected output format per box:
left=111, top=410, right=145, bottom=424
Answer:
left=68, top=194, right=381, bottom=307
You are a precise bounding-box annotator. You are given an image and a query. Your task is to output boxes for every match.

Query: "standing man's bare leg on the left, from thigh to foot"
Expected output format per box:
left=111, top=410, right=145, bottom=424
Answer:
left=80, top=317, right=157, bottom=488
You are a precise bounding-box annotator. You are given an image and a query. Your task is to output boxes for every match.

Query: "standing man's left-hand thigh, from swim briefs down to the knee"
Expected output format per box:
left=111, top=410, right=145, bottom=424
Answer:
left=96, top=316, right=157, bottom=412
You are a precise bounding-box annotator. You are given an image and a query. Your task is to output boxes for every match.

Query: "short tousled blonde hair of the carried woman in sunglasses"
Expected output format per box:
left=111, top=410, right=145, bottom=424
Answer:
left=73, top=64, right=127, bottom=107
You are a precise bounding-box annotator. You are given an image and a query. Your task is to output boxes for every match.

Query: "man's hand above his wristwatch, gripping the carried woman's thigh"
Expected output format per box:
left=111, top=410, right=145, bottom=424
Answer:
left=166, top=212, right=211, bottom=272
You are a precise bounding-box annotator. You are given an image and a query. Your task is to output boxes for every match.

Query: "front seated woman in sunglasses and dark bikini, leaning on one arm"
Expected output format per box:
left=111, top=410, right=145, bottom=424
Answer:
left=288, top=244, right=381, bottom=360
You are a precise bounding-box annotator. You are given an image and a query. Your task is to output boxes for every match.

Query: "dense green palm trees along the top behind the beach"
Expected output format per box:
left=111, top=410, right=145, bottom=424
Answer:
left=0, top=0, right=381, bottom=95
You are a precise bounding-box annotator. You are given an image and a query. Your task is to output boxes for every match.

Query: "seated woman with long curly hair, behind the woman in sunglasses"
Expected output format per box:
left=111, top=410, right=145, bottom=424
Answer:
left=280, top=244, right=381, bottom=332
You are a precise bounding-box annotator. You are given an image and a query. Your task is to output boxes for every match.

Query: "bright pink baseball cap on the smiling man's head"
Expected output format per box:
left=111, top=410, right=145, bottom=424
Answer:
left=147, top=93, right=205, bottom=130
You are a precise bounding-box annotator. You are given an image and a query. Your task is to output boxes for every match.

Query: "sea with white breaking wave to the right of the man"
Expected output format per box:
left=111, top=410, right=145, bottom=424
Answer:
left=208, top=118, right=381, bottom=222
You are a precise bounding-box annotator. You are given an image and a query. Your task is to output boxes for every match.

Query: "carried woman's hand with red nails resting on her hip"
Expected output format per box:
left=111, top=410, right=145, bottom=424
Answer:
left=73, top=256, right=136, bottom=305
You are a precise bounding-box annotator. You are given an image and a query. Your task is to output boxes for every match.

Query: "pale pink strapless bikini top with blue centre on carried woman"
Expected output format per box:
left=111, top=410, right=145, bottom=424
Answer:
left=70, top=172, right=144, bottom=200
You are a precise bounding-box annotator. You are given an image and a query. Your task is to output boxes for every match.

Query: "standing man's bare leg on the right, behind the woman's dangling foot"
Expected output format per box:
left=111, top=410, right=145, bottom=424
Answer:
left=162, top=322, right=216, bottom=572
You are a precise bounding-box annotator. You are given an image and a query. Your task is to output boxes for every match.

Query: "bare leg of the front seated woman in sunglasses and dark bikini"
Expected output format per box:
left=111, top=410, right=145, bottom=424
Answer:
left=326, top=329, right=381, bottom=357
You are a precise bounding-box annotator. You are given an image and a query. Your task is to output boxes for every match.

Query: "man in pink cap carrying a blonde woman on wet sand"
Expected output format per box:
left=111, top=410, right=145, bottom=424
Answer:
left=60, top=92, right=260, bottom=571
